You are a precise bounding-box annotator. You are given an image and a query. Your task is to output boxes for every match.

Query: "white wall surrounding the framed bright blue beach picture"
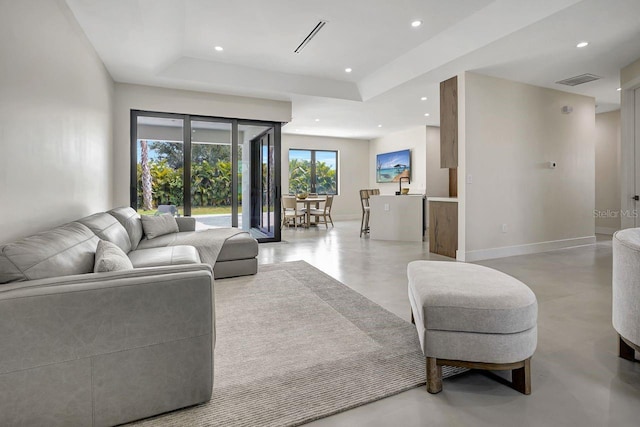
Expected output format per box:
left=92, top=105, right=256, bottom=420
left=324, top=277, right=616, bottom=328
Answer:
left=368, top=126, right=424, bottom=194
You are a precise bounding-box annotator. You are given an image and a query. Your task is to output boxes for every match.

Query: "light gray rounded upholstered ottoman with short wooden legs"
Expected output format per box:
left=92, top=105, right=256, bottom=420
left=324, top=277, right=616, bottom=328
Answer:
left=407, top=261, right=538, bottom=394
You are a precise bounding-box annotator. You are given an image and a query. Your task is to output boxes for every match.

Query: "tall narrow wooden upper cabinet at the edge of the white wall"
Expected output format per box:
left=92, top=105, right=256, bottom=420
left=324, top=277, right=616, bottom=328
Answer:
left=440, top=76, right=458, bottom=169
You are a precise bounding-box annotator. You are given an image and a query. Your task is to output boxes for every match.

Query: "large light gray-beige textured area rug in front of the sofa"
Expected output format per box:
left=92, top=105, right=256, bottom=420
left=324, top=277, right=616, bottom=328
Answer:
left=135, top=261, right=454, bottom=427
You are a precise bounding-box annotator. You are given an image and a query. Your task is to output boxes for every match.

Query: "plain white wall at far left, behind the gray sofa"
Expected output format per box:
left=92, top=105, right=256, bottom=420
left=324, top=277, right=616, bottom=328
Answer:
left=0, top=0, right=113, bottom=242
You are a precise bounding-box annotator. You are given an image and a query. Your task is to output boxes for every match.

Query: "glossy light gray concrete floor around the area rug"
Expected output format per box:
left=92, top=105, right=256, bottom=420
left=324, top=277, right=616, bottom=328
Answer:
left=259, top=221, right=640, bottom=427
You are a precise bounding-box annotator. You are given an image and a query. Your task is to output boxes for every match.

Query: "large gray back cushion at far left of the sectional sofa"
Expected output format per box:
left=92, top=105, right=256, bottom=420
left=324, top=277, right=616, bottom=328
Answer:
left=0, top=222, right=100, bottom=283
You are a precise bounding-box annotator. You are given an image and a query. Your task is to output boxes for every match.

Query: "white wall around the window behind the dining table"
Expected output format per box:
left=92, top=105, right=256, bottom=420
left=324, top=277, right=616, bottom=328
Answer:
left=282, top=134, right=370, bottom=220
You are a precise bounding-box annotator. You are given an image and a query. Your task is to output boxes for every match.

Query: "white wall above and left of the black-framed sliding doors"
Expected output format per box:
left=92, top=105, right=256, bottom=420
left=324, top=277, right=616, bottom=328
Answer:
left=114, top=83, right=291, bottom=206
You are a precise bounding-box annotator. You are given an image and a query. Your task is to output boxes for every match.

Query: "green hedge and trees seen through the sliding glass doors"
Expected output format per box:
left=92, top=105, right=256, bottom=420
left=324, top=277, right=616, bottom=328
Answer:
left=137, top=141, right=236, bottom=211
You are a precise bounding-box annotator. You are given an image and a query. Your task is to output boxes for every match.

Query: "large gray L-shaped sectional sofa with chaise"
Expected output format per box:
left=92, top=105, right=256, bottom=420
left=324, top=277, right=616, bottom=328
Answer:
left=0, top=208, right=258, bottom=426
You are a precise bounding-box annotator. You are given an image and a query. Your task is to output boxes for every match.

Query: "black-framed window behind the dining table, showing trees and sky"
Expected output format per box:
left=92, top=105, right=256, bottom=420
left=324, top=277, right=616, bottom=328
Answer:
left=289, top=149, right=338, bottom=194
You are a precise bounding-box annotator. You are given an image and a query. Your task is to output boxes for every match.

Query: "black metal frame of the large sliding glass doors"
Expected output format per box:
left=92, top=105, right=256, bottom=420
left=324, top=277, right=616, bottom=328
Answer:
left=129, top=110, right=282, bottom=242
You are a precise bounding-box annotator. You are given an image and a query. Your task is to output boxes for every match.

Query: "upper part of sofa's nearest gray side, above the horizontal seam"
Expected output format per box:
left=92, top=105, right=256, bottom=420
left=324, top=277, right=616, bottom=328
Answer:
left=0, top=264, right=215, bottom=374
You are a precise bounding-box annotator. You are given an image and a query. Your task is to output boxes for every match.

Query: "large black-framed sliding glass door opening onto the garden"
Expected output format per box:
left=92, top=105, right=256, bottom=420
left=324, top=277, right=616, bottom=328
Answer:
left=131, top=111, right=280, bottom=241
